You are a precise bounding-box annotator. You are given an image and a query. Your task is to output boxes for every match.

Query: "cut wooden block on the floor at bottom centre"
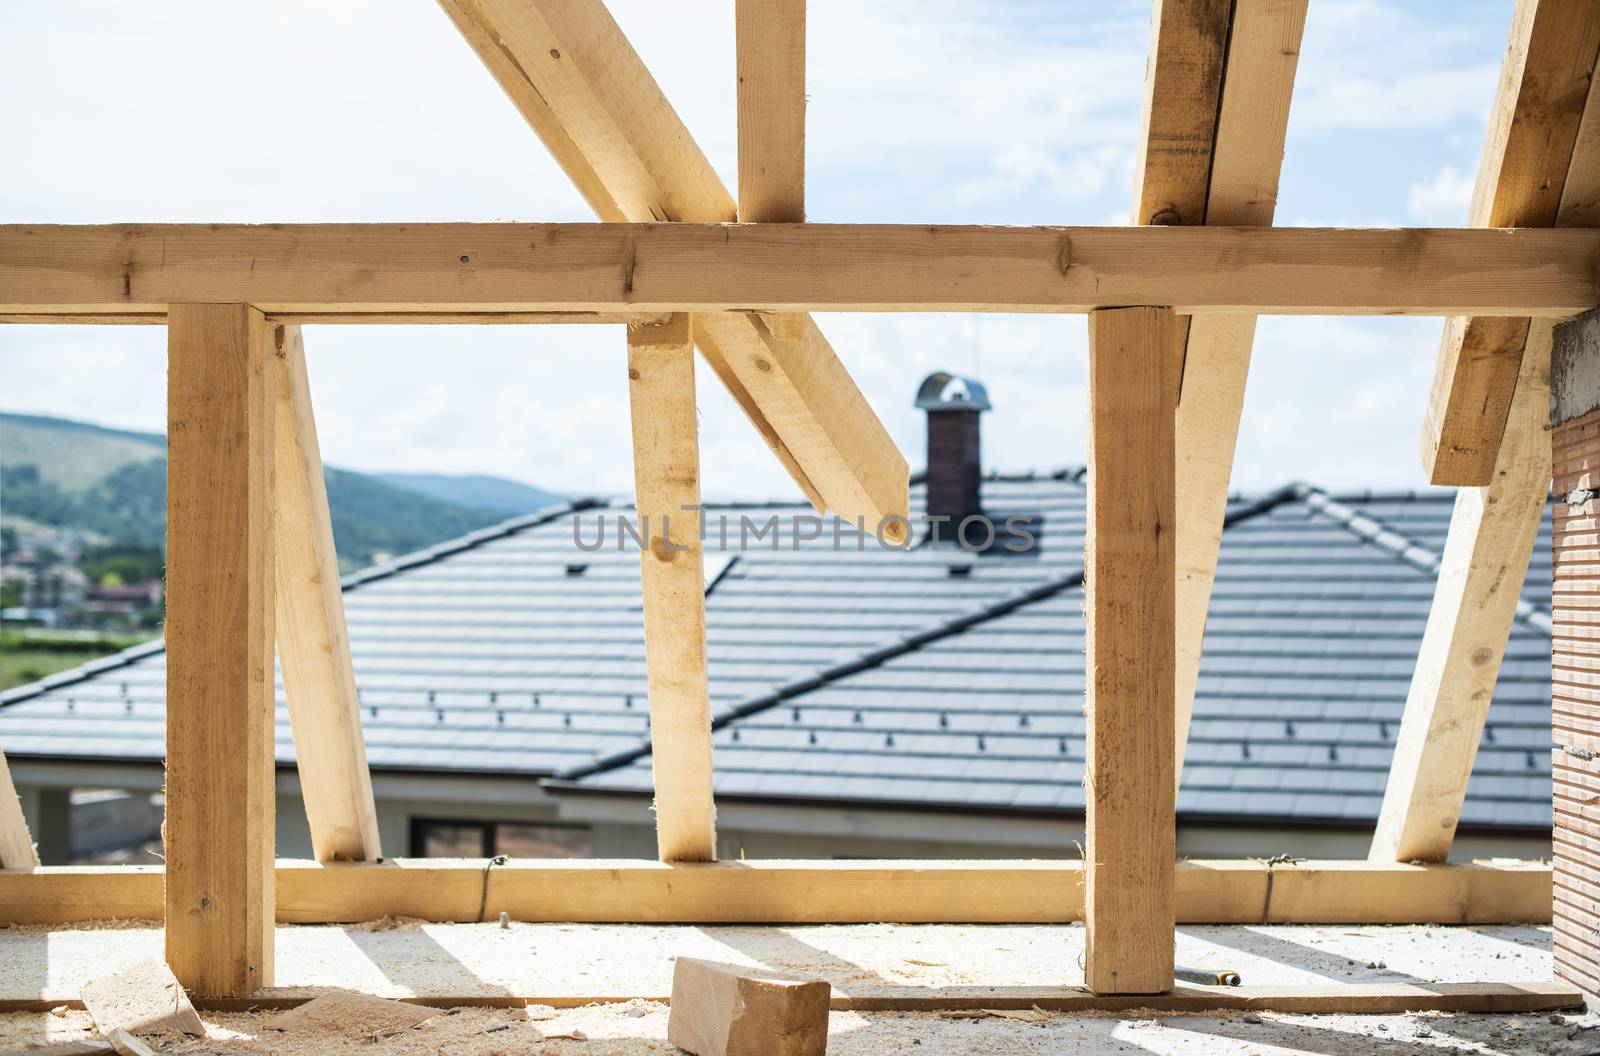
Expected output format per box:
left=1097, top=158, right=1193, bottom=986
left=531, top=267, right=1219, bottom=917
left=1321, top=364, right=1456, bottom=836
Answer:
left=667, top=957, right=832, bottom=1056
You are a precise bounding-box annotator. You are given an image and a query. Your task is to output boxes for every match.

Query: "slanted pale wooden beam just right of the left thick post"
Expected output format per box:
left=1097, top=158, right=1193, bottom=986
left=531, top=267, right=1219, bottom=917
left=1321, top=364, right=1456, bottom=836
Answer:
left=274, top=325, right=382, bottom=862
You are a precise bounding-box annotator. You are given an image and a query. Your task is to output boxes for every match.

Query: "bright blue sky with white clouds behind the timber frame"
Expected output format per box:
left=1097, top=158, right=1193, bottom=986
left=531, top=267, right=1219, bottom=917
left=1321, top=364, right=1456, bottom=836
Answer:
left=0, top=0, right=1512, bottom=499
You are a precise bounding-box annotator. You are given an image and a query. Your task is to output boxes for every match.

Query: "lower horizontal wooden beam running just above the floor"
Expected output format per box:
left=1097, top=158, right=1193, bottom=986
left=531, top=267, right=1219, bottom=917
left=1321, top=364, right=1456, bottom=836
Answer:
left=0, top=858, right=1552, bottom=926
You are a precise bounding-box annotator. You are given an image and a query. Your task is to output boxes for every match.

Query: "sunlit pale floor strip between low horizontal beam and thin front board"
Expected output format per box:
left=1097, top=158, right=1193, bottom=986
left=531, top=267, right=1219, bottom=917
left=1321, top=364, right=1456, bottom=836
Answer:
left=0, top=922, right=1552, bottom=1003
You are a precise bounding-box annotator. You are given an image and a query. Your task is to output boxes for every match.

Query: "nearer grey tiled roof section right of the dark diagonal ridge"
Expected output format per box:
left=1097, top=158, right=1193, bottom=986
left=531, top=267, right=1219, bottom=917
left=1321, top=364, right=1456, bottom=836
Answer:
left=557, top=482, right=1550, bottom=829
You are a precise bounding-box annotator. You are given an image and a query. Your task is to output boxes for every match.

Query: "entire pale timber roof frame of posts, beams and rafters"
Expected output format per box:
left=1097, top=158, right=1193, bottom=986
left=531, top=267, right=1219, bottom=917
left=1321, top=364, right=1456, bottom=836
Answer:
left=0, top=0, right=1600, bottom=995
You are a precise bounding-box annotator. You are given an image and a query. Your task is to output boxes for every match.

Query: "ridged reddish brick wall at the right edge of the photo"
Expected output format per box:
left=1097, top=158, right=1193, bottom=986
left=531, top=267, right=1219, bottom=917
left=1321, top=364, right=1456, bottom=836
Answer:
left=1550, top=404, right=1600, bottom=995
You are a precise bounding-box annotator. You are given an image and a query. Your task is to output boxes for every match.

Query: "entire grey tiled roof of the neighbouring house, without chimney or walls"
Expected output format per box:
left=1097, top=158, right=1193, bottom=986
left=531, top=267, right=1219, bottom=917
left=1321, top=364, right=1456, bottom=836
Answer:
left=0, top=472, right=1550, bottom=827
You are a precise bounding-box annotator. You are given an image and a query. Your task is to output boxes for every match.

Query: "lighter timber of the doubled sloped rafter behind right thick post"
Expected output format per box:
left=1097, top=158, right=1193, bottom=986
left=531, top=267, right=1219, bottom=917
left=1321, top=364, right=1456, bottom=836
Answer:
left=1171, top=0, right=1309, bottom=786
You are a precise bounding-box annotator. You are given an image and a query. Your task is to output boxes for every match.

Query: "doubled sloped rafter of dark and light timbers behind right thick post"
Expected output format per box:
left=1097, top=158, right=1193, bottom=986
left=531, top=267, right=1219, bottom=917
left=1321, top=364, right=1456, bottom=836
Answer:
left=1133, top=0, right=1307, bottom=781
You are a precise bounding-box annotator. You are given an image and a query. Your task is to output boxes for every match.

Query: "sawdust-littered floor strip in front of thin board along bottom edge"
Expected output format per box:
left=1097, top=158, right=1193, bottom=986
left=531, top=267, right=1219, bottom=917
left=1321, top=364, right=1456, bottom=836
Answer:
left=0, top=1002, right=1600, bottom=1056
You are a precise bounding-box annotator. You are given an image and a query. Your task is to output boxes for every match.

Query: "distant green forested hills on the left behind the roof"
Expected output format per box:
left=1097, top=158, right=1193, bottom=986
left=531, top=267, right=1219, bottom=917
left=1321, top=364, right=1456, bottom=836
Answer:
left=0, top=413, right=542, bottom=570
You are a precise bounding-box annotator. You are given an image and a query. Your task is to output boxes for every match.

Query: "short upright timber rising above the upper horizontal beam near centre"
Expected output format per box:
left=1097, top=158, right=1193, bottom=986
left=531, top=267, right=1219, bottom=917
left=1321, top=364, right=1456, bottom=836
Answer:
left=733, top=0, right=806, bottom=224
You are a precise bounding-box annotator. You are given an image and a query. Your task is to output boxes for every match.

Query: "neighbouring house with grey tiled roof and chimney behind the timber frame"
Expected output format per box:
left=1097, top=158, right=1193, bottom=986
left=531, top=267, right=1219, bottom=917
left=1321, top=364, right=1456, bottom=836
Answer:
left=0, top=379, right=1550, bottom=858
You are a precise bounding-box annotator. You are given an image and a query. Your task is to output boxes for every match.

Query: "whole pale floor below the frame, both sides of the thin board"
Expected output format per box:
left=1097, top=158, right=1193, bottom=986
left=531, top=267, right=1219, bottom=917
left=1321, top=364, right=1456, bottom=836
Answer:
left=0, top=922, right=1600, bottom=1056
